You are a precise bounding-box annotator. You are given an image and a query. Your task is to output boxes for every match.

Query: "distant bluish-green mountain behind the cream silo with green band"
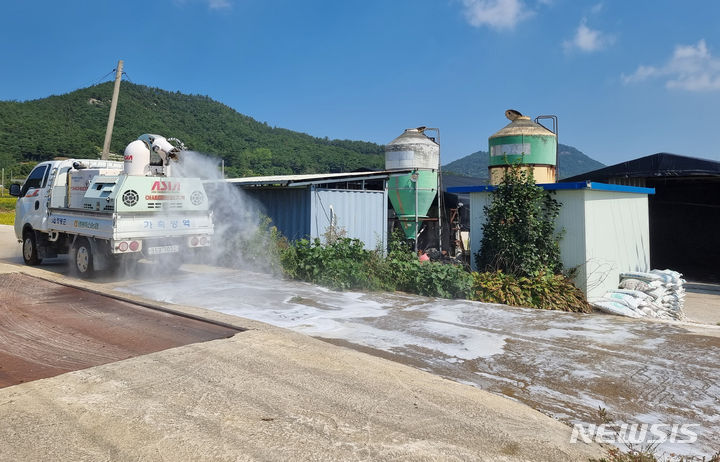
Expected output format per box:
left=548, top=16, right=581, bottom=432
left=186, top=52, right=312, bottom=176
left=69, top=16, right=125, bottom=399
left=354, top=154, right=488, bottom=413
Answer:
left=443, top=144, right=605, bottom=181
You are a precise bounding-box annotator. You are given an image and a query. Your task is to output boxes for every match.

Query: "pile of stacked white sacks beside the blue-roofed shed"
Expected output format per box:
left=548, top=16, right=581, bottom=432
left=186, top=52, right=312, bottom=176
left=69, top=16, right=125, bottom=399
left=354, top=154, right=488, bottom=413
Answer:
left=590, top=270, right=685, bottom=320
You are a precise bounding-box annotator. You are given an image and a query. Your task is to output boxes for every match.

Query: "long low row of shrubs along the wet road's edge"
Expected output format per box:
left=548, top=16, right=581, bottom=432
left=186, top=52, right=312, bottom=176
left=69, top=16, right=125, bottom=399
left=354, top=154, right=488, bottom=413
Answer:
left=245, top=219, right=591, bottom=312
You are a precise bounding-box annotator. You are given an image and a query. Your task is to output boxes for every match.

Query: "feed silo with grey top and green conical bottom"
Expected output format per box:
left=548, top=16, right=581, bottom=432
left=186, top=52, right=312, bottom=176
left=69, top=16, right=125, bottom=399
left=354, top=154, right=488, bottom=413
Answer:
left=385, top=127, right=440, bottom=239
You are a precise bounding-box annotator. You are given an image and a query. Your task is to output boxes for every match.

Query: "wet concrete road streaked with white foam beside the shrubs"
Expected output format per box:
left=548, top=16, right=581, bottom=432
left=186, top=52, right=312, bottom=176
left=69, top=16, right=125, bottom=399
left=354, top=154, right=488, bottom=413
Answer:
left=2, top=225, right=720, bottom=455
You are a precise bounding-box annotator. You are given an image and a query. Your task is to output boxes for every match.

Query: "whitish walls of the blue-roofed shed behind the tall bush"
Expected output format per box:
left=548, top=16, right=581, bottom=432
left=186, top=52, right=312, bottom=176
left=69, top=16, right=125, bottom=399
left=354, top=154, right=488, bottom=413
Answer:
left=470, top=189, right=650, bottom=298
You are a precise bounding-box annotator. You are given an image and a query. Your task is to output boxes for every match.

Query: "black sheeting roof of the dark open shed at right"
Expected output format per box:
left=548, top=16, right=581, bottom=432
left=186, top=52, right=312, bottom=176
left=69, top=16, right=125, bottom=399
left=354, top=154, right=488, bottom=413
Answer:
left=561, top=152, right=720, bottom=182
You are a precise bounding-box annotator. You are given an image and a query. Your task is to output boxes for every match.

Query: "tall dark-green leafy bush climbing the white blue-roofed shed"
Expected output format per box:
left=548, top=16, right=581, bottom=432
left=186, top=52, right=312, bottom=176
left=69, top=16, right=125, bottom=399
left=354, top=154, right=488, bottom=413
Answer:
left=475, top=165, right=562, bottom=276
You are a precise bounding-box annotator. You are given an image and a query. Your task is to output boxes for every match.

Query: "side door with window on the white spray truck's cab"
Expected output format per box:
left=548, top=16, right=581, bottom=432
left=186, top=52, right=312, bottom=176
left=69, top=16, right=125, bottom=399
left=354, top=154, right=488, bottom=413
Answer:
left=15, top=164, right=50, bottom=236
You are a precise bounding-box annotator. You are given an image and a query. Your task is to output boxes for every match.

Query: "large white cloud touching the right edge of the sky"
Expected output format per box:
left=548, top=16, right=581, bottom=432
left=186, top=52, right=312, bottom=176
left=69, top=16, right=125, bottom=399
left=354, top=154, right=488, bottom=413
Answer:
left=621, top=39, right=720, bottom=91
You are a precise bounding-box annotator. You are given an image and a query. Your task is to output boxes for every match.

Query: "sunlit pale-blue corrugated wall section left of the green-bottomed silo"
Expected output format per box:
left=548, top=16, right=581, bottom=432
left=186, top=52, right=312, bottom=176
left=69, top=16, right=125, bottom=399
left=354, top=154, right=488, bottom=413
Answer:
left=310, top=189, right=388, bottom=250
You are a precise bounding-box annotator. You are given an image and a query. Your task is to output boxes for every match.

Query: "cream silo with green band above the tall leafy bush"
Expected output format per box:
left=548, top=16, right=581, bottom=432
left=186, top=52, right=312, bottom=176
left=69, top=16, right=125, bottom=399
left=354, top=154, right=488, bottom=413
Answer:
left=488, top=109, right=557, bottom=185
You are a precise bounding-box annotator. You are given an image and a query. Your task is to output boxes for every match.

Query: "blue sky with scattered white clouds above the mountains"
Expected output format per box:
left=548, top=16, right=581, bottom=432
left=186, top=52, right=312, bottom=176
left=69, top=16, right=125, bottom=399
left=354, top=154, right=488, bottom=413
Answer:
left=0, top=0, right=720, bottom=164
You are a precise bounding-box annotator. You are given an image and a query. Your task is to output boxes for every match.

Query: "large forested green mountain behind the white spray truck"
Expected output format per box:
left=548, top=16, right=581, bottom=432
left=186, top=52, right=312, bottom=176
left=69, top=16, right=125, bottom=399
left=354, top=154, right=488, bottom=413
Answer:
left=0, top=82, right=384, bottom=176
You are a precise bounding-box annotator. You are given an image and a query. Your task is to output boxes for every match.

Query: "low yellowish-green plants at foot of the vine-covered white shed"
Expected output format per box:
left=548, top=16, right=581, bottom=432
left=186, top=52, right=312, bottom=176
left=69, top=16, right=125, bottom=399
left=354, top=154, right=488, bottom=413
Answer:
left=470, top=271, right=592, bottom=313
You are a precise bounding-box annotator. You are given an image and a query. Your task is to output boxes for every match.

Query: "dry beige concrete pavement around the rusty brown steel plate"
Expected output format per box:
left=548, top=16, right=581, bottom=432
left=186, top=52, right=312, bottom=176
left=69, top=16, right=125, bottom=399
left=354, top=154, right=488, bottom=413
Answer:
left=0, top=228, right=604, bottom=462
